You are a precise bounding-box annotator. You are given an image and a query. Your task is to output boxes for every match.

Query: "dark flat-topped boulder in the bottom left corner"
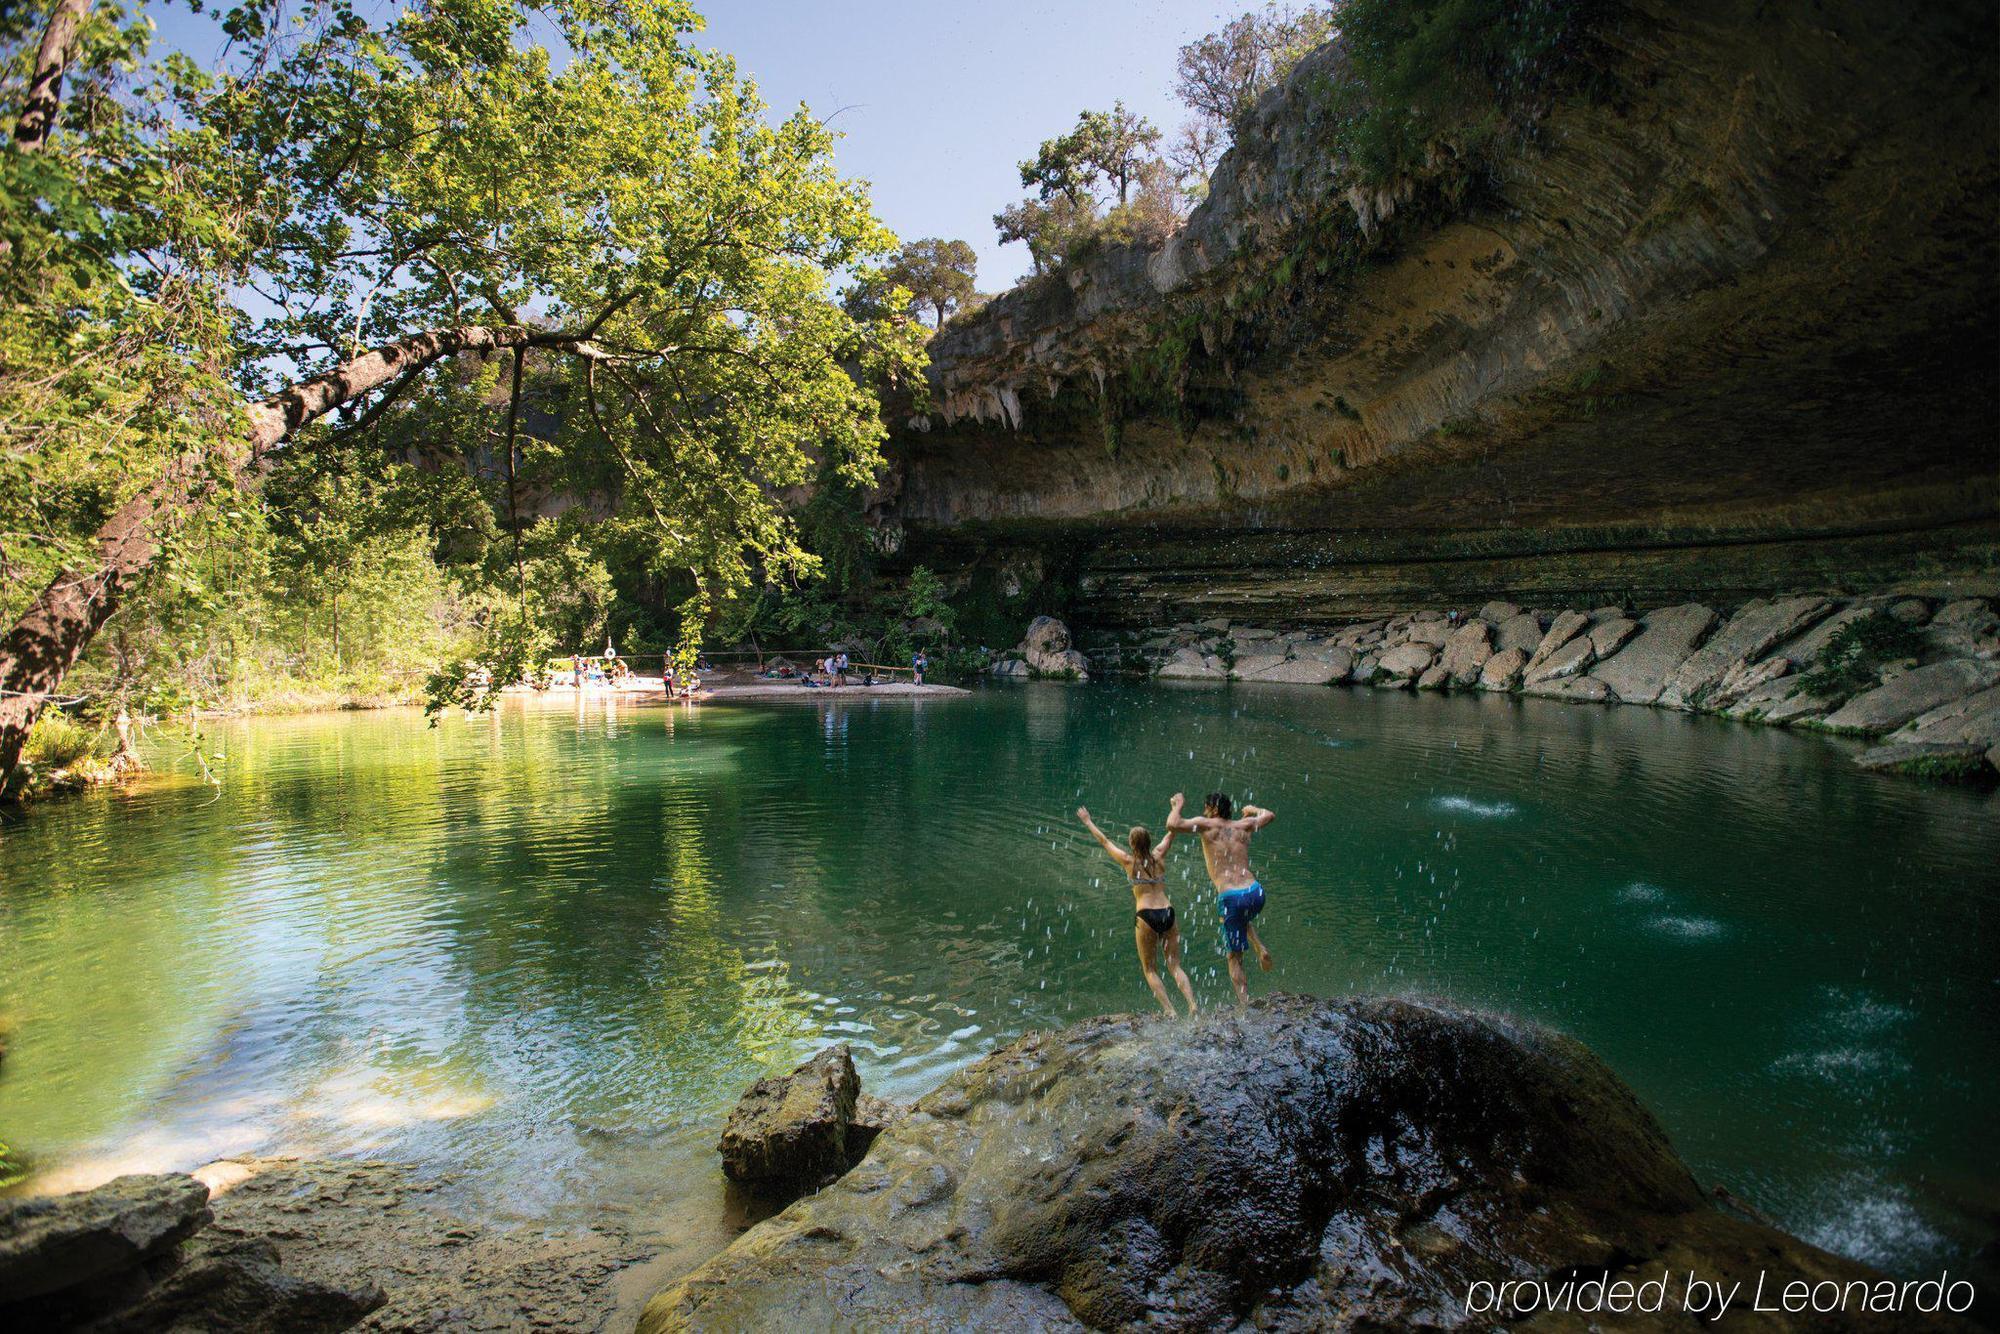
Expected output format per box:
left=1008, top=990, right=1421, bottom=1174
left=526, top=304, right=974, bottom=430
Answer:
left=0, top=1174, right=210, bottom=1306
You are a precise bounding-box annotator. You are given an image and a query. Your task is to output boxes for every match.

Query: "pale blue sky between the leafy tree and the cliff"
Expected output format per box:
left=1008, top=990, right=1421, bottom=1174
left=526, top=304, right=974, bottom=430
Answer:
left=700, top=0, right=1252, bottom=292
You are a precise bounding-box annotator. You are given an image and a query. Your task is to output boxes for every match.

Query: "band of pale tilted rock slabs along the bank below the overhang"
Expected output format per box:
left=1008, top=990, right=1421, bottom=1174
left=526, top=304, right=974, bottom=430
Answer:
left=992, top=594, right=2000, bottom=780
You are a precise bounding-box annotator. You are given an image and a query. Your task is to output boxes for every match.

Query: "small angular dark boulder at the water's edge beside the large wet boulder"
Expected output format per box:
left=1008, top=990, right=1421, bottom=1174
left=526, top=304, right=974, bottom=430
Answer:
left=716, top=1044, right=866, bottom=1196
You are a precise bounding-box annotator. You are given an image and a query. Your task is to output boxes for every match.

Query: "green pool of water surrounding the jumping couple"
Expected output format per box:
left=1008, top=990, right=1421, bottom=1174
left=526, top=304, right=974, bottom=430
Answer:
left=0, top=686, right=2000, bottom=1270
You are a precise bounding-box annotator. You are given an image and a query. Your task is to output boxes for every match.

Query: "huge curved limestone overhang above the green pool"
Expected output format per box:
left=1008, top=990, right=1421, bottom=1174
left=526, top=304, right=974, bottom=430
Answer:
left=880, top=0, right=2000, bottom=628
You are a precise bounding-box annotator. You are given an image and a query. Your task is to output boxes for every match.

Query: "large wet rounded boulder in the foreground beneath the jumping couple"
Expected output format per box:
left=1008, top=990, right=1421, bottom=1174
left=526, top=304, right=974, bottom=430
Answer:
left=640, top=996, right=1878, bottom=1334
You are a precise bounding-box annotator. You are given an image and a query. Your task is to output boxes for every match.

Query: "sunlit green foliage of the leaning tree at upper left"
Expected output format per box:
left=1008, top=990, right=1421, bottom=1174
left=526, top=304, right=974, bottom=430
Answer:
left=0, top=0, right=920, bottom=768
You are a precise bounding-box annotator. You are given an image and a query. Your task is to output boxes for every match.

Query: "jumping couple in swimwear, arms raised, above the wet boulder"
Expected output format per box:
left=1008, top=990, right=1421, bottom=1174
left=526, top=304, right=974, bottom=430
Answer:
left=1076, top=792, right=1276, bottom=1018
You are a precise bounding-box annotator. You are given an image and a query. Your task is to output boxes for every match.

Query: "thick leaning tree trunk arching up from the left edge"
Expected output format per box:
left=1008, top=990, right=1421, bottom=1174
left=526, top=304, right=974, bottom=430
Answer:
left=0, top=324, right=540, bottom=778
